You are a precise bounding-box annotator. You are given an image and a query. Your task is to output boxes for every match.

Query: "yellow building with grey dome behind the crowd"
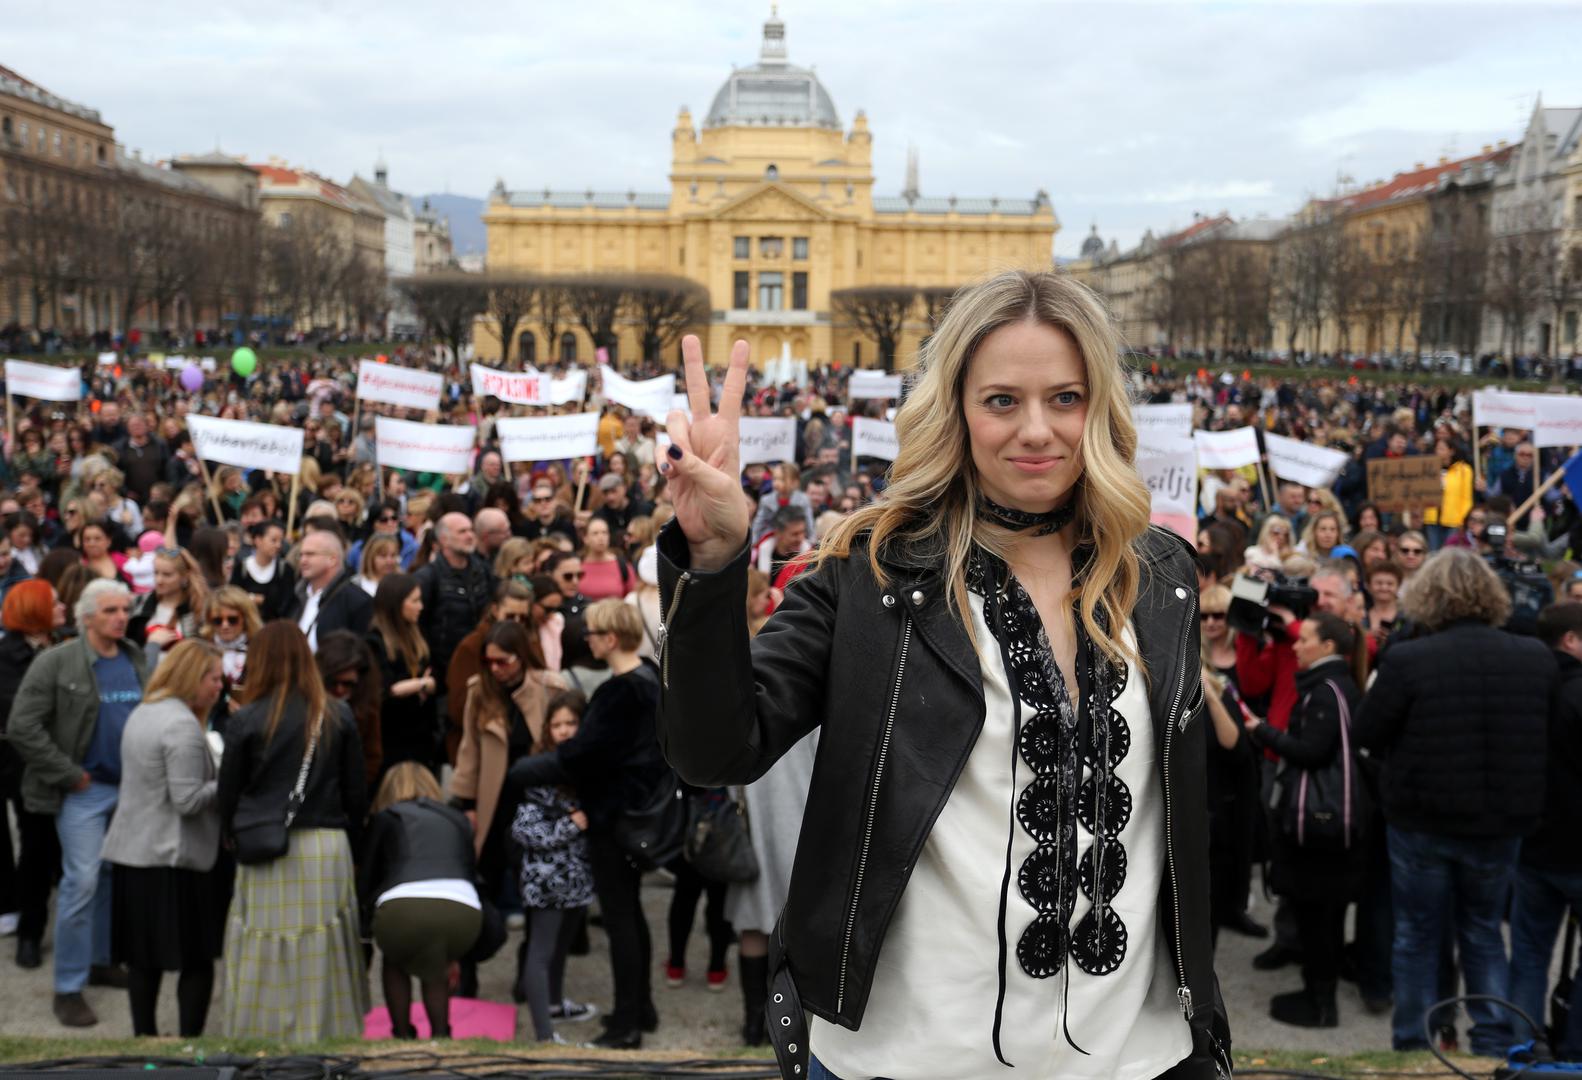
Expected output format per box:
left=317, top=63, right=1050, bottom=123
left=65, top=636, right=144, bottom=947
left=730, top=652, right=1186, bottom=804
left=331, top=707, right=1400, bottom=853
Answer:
left=475, top=16, right=1060, bottom=367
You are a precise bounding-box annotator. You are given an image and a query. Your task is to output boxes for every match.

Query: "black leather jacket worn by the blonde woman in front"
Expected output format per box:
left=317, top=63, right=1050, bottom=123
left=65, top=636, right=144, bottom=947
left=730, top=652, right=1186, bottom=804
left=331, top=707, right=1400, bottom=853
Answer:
left=658, top=523, right=1231, bottom=1080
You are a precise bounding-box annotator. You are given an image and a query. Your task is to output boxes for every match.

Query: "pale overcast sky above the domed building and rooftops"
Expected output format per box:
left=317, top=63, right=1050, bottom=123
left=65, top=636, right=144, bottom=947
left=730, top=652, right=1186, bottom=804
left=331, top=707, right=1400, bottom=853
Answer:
left=0, top=0, right=1582, bottom=255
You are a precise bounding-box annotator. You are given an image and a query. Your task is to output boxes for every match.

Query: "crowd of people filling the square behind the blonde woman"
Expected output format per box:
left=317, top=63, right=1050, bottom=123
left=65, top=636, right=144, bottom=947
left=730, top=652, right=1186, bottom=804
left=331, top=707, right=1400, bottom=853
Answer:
left=0, top=322, right=1582, bottom=1055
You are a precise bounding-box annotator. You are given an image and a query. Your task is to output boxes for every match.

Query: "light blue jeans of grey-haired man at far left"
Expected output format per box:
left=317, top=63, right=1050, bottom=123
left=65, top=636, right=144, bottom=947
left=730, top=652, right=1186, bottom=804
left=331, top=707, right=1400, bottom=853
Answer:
left=55, top=781, right=120, bottom=993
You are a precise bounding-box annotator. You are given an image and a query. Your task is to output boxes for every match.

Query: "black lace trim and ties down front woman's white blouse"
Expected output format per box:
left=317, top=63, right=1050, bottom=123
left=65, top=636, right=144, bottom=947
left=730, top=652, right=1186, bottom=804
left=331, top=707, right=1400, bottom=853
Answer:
left=967, top=549, right=1131, bottom=1066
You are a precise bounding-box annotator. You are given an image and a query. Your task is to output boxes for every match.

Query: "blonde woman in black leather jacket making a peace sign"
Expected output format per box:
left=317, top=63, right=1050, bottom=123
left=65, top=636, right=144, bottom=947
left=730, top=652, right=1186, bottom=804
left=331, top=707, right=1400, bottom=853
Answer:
left=658, top=270, right=1229, bottom=1077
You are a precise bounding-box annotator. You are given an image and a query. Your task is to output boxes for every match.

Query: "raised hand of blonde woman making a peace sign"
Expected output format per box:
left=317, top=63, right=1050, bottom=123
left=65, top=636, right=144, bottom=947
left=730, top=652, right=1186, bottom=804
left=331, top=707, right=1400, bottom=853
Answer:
left=660, top=334, right=751, bottom=569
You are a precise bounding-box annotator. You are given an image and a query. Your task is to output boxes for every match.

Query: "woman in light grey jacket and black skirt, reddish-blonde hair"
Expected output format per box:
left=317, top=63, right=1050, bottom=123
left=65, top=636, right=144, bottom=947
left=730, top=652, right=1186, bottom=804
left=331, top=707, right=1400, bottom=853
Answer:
left=103, top=640, right=231, bottom=1039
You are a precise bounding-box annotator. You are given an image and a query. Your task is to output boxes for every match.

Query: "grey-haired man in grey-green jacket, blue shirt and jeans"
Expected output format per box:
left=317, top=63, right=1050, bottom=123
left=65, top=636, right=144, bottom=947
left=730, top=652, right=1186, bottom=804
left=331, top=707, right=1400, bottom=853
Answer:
left=6, top=580, right=144, bottom=1028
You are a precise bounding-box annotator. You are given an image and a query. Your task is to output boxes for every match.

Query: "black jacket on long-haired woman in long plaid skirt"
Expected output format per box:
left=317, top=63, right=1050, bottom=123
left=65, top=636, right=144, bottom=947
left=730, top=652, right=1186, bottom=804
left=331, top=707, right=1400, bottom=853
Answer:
left=218, top=695, right=369, bottom=849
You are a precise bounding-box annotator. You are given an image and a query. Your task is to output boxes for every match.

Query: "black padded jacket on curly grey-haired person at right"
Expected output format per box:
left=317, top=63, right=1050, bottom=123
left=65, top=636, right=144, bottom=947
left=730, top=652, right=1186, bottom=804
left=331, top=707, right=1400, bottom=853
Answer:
left=1354, top=620, right=1555, bottom=836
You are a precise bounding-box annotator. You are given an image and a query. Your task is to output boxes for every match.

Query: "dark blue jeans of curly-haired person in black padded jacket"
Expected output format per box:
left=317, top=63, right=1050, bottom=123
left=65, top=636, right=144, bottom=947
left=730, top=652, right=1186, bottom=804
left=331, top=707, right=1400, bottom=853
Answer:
left=1389, top=825, right=1520, bottom=1058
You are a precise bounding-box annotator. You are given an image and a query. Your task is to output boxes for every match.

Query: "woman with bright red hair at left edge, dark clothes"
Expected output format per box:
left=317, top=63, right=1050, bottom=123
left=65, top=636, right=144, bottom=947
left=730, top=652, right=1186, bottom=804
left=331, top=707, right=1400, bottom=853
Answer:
left=0, top=577, right=66, bottom=968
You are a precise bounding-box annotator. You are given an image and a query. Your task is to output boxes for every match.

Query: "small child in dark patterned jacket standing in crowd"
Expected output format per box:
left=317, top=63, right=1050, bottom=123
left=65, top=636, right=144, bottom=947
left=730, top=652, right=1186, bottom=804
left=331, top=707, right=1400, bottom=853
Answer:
left=511, top=689, right=595, bottom=1042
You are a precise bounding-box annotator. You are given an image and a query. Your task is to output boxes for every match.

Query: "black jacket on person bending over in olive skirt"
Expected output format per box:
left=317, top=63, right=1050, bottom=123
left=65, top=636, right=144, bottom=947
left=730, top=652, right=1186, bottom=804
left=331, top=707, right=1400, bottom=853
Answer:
left=358, top=799, right=473, bottom=916
